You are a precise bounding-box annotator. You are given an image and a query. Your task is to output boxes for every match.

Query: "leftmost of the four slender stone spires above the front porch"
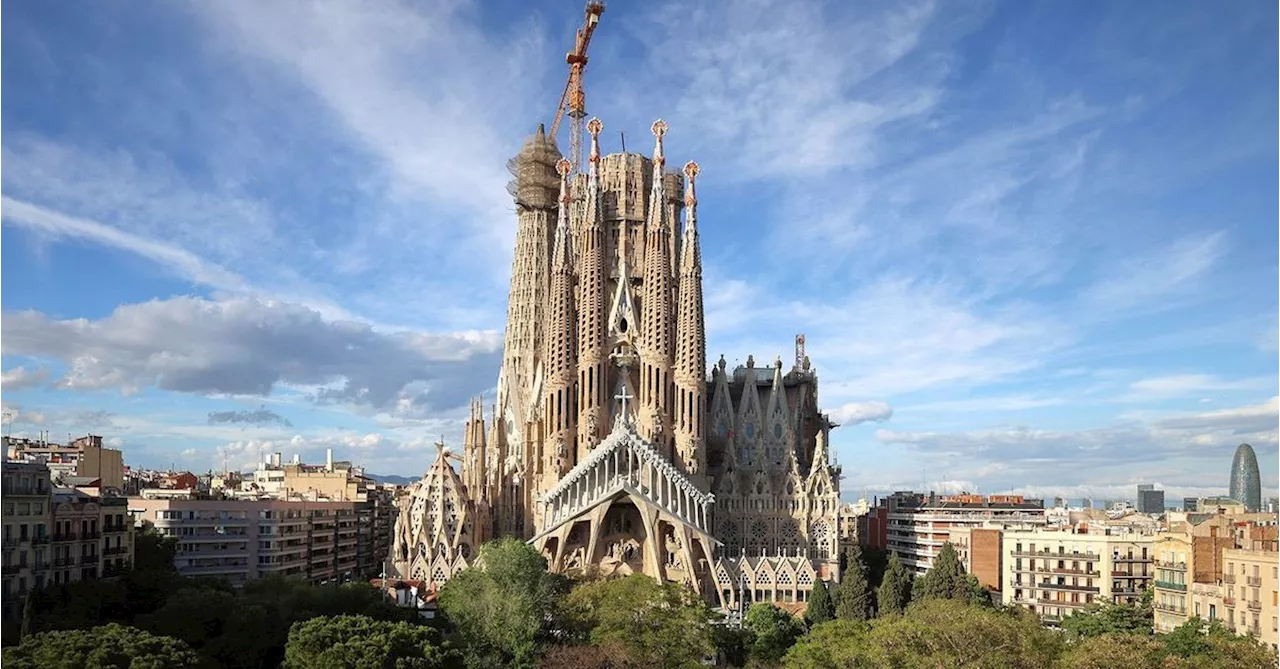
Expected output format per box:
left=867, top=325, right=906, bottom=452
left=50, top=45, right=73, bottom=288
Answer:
left=543, top=160, right=577, bottom=486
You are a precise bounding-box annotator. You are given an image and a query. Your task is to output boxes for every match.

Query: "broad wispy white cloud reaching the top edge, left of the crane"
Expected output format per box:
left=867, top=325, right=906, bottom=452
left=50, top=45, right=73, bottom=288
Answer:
left=196, top=0, right=558, bottom=272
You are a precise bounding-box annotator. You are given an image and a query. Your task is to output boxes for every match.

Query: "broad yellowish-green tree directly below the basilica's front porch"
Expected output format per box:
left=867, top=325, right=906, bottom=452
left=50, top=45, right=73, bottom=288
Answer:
left=563, top=574, right=716, bottom=669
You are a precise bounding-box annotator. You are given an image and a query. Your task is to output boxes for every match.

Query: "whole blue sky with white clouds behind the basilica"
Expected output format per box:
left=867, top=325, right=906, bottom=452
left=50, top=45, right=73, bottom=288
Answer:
left=0, top=0, right=1280, bottom=498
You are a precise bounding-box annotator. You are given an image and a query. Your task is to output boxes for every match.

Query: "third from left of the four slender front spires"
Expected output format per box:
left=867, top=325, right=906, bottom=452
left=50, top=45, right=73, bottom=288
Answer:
left=637, top=119, right=672, bottom=452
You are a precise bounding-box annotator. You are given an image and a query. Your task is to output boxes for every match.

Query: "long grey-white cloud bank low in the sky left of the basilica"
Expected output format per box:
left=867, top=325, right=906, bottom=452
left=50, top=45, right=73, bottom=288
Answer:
left=0, top=298, right=500, bottom=411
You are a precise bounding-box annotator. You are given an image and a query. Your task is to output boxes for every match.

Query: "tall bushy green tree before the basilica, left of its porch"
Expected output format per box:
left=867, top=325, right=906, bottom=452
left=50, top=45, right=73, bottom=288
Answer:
left=439, top=539, right=567, bottom=666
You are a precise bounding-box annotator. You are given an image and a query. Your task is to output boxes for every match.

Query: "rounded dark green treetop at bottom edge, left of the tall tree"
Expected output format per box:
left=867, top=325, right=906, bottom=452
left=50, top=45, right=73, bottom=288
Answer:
left=283, top=615, right=461, bottom=669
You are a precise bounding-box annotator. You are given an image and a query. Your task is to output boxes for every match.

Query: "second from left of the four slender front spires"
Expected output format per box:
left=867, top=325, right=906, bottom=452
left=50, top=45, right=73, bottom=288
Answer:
left=577, top=119, right=609, bottom=460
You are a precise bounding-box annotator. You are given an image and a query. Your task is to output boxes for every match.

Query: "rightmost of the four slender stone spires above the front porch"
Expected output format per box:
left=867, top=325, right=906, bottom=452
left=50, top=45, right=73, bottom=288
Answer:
left=675, top=161, right=707, bottom=476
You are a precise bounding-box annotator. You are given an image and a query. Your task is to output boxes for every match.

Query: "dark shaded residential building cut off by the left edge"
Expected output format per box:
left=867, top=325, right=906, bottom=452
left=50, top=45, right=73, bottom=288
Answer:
left=0, top=458, right=52, bottom=626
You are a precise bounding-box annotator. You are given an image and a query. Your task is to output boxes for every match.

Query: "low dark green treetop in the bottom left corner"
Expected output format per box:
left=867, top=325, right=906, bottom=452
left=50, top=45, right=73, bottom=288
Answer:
left=0, top=623, right=206, bottom=669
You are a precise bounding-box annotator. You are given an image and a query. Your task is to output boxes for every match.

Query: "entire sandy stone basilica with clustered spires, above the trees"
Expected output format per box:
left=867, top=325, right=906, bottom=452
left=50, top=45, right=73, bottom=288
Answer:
left=393, top=119, right=841, bottom=608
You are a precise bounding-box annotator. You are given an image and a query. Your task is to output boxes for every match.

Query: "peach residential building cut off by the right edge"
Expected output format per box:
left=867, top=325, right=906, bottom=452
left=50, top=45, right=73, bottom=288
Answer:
left=1222, top=549, right=1280, bottom=649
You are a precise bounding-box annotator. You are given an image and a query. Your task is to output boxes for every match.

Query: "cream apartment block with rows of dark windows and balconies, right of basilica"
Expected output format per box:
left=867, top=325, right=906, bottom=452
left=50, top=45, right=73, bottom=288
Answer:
left=1001, top=526, right=1155, bottom=623
